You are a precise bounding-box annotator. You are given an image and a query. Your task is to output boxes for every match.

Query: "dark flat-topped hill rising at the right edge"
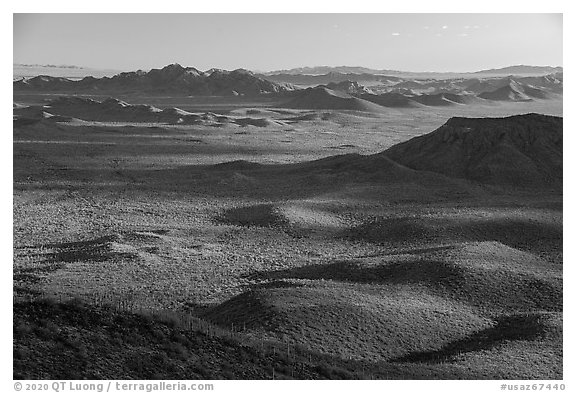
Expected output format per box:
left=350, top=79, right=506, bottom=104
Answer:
left=381, top=114, right=562, bottom=185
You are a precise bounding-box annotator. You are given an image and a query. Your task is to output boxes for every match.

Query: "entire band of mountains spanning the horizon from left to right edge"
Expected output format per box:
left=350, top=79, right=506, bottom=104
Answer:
left=13, top=64, right=563, bottom=104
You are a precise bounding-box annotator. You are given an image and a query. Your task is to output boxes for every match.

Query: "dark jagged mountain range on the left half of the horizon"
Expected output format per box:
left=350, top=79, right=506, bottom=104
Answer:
left=13, top=64, right=293, bottom=96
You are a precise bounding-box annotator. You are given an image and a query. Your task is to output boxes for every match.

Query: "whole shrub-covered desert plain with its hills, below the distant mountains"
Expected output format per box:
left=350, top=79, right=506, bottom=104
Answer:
left=13, top=66, right=563, bottom=379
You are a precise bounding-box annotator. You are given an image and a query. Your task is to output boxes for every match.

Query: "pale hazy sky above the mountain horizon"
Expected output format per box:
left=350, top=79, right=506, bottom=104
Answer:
left=13, top=14, right=562, bottom=71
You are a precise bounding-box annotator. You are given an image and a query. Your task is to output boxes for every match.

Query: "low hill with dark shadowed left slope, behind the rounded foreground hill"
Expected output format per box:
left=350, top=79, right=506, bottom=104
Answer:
left=244, top=248, right=563, bottom=312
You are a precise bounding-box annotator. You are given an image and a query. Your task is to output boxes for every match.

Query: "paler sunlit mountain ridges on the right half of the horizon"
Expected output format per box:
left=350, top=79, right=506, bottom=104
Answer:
left=286, top=74, right=563, bottom=112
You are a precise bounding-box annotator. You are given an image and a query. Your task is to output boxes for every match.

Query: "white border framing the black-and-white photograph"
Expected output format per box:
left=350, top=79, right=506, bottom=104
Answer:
left=0, top=0, right=576, bottom=392
